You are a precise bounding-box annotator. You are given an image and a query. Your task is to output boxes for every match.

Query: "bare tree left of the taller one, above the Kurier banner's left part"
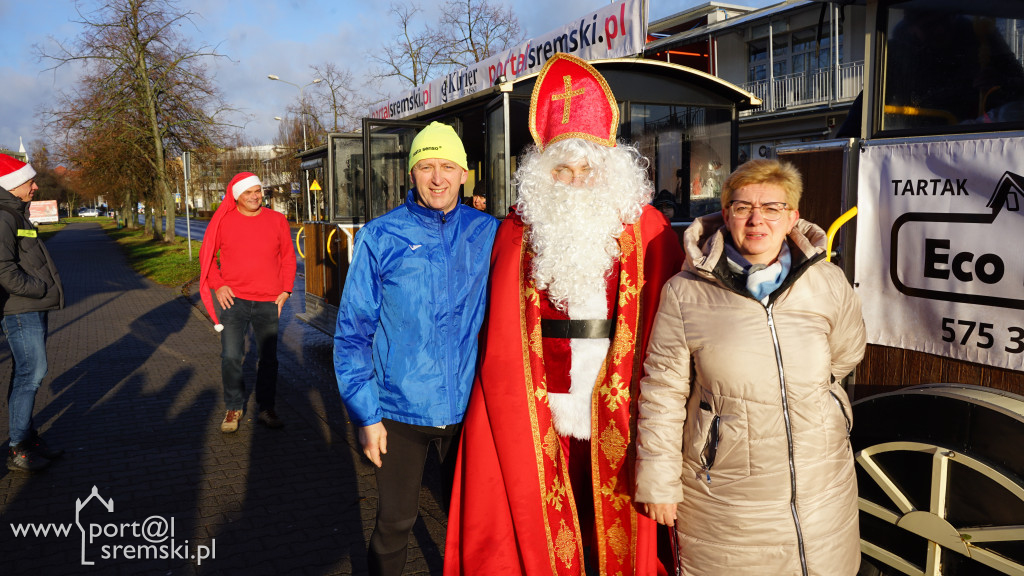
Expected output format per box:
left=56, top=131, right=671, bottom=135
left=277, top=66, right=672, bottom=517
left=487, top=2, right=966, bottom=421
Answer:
left=371, top=3, right=441, bottom=86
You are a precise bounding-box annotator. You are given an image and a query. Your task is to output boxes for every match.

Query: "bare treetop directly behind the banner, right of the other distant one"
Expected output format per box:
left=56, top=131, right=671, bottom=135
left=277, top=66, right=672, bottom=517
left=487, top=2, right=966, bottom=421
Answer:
left=438, top=0, right=524, bottom=69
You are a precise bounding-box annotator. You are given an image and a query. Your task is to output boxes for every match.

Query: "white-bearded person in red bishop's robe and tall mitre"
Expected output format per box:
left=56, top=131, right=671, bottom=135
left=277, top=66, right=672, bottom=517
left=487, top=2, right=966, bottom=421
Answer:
left=444, top=53, right=683, bottom=576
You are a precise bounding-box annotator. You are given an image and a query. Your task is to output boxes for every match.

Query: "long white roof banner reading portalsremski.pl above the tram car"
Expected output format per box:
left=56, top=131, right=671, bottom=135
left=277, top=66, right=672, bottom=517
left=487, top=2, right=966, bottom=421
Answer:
left=370, top=0, right=647, bottom=120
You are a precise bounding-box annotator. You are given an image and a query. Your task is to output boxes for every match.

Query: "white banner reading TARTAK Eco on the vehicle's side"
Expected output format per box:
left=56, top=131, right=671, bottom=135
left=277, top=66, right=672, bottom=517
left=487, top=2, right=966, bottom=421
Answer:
left=856, top=138, right=1024, bottom=370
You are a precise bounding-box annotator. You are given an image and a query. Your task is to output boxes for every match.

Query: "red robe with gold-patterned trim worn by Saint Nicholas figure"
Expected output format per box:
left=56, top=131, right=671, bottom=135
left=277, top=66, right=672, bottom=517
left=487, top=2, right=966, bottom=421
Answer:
left=444, top=206, right=683, bottom=576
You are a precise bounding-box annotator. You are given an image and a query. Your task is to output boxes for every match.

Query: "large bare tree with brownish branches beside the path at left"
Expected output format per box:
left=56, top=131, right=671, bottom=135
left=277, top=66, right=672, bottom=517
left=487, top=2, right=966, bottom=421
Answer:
left=42, top=0, right=226, bottom=241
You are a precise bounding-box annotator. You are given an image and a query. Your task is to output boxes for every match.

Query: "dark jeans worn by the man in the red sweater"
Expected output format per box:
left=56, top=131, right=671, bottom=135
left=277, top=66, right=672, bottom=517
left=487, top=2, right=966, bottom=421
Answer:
left=219, top=298, right=279, bottom=410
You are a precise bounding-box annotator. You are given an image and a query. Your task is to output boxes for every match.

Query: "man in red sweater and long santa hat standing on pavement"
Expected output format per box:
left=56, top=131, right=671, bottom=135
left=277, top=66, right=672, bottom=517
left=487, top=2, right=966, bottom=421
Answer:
left=200, top=172, right=295, bottom=433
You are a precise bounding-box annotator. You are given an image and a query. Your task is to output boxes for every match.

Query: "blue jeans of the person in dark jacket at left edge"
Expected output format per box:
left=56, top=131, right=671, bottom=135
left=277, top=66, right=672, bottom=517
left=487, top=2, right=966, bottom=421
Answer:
left=0, top=312, right=47, bottom=447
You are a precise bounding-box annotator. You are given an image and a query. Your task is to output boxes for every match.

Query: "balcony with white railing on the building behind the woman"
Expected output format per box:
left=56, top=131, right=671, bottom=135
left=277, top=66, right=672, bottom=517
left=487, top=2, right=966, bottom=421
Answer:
left=739, top=60, right=864, bottom=117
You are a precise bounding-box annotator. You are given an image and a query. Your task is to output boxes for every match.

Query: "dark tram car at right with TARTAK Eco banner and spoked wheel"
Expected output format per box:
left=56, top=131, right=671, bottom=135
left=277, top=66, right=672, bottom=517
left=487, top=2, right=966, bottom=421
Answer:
left=776, top=0, right=1024, bottom=576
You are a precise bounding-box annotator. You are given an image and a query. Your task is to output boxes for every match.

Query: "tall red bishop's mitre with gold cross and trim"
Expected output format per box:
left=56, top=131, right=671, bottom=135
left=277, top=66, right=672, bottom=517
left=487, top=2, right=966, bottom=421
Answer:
left=529, top=52, right=618, bottom=151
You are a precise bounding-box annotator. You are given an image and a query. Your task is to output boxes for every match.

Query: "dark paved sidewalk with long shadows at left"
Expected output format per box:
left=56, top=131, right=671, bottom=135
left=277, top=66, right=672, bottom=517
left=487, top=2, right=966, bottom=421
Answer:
left=0, top=222, right=444, bottom=576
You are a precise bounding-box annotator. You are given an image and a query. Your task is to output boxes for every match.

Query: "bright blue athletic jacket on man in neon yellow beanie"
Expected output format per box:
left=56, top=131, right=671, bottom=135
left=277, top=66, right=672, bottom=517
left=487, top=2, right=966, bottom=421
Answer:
left=334, top=191, right=498, bottom=426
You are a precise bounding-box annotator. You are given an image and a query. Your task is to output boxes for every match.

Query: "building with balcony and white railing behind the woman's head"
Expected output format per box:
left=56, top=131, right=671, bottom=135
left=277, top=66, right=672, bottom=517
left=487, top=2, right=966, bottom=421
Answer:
left=644, top=0, right=866, bottom=161
